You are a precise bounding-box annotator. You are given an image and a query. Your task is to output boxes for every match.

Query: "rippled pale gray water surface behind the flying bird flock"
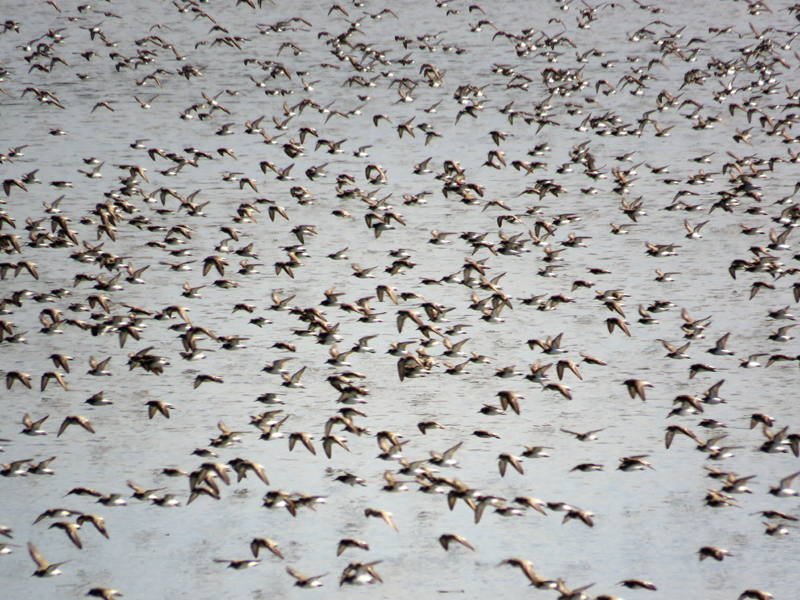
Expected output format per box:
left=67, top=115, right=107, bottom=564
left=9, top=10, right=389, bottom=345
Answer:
left=0, top=0, right=800, bottom=599
